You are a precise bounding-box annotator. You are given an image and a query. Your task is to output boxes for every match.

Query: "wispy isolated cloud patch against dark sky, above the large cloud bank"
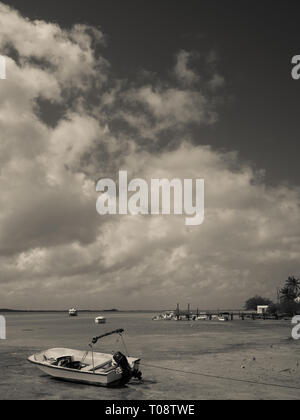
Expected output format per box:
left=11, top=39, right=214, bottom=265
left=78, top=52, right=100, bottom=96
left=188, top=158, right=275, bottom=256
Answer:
left=109, top=51, right=225, bottom=147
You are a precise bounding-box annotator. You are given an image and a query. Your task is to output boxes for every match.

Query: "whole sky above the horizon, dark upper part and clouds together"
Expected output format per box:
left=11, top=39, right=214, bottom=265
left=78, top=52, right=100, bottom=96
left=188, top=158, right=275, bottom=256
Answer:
left=0, top=0, right=300, bottom=309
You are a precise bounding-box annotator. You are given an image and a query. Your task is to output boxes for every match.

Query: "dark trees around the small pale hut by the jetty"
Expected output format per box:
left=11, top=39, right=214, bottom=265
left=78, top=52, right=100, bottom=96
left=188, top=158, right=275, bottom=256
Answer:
left=245, top=276, right=300, bottom=316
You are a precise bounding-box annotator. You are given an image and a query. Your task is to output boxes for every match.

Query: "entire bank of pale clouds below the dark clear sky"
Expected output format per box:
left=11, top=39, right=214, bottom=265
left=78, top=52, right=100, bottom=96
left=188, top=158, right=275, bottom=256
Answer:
left=0, top=3, right=300, bottom=308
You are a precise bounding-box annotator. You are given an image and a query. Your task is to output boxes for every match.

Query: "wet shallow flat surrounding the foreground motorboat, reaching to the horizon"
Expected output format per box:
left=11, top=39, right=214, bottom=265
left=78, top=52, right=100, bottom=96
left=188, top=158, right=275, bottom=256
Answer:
left=0, top=313, right=300, bottom=400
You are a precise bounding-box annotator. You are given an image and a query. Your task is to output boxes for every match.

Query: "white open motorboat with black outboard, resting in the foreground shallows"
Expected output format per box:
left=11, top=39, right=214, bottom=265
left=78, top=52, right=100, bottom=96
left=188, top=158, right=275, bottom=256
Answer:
left=28, top=329, right=142, bottom=386
